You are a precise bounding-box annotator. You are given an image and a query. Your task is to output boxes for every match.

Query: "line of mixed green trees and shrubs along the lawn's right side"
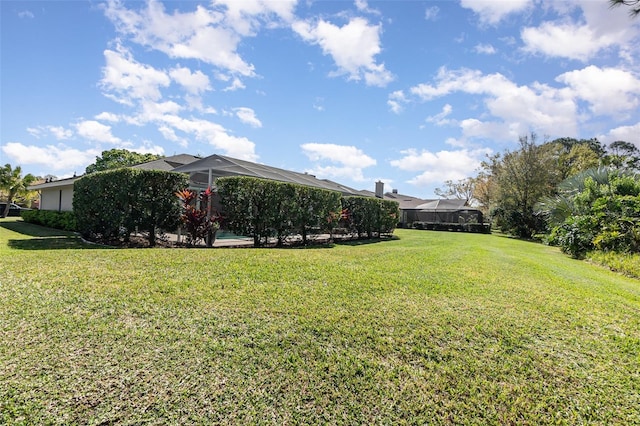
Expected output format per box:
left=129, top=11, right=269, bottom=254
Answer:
left=436, top=133, right=640, bottom=257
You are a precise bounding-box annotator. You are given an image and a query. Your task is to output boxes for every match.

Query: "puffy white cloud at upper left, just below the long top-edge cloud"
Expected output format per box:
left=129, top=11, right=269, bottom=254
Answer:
left=100, top=46, right=171, bottom=105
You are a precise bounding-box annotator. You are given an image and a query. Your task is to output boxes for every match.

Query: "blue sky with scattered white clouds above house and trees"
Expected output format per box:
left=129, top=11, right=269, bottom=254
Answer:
left=0, top=0, right=640, bottom=198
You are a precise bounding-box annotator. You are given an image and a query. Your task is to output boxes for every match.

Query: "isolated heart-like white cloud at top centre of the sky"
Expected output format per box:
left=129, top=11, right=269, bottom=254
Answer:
left=293, top=17, right=393, bottom=87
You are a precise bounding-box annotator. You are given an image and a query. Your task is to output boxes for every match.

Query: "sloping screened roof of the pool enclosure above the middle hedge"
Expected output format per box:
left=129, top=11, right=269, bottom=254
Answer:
left=173, top=154, right=363, bottom=195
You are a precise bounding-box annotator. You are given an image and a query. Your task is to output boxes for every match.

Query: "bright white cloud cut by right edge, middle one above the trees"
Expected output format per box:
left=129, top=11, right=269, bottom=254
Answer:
left=556, top=65, right=640, bottom=116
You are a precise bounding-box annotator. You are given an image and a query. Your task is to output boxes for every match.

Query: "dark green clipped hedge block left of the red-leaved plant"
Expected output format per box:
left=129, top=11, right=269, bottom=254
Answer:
left=73, top=168, right=189, bottom=246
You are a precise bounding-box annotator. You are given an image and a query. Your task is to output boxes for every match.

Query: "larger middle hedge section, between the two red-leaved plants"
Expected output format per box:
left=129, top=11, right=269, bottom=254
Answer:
left=216, top=176, right=341, bottom=247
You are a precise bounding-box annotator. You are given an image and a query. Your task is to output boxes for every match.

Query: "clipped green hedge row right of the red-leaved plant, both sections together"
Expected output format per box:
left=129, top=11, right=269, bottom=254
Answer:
left=216, top=176, right=399, bottom=247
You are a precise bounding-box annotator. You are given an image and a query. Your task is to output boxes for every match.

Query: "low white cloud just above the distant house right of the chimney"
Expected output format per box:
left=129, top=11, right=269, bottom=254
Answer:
left=390, top=148, right=492, bottom=186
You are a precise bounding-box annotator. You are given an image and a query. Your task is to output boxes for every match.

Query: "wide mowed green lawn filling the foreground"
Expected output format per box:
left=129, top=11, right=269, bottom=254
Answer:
left=0, top=221, right=640, bottom=425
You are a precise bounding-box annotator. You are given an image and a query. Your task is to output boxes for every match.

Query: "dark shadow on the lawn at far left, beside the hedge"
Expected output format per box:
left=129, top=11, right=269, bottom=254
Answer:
left=0, top=221, right=105, bottom=250
